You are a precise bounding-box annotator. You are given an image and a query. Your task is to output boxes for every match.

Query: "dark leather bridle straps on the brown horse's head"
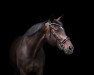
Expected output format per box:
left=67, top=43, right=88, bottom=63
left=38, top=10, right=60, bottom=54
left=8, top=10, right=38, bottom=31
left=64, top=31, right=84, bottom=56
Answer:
left=49, top=23, right=70, bottom=46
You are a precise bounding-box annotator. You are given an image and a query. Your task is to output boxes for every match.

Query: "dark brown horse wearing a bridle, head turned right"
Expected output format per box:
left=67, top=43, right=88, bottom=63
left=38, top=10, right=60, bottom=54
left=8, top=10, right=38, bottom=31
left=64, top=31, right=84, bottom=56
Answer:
left=10, top=17, right=74, bottom=75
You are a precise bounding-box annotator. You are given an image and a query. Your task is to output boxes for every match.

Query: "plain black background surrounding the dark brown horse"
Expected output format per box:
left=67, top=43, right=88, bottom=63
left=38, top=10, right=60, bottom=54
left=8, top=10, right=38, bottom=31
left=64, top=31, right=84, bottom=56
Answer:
left=1, top=1, right=91, bottom=75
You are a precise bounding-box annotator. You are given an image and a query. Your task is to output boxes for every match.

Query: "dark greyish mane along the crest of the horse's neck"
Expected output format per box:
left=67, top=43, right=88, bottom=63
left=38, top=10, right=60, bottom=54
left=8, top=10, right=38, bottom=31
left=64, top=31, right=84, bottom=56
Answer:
left=24, top=22, right=44, bottom=35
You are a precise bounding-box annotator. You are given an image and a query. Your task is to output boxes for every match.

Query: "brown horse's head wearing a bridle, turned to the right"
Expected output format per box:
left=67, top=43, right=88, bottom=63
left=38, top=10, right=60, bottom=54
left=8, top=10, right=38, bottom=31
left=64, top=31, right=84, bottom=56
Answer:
left=45, top=16, right=74, bottom=54
